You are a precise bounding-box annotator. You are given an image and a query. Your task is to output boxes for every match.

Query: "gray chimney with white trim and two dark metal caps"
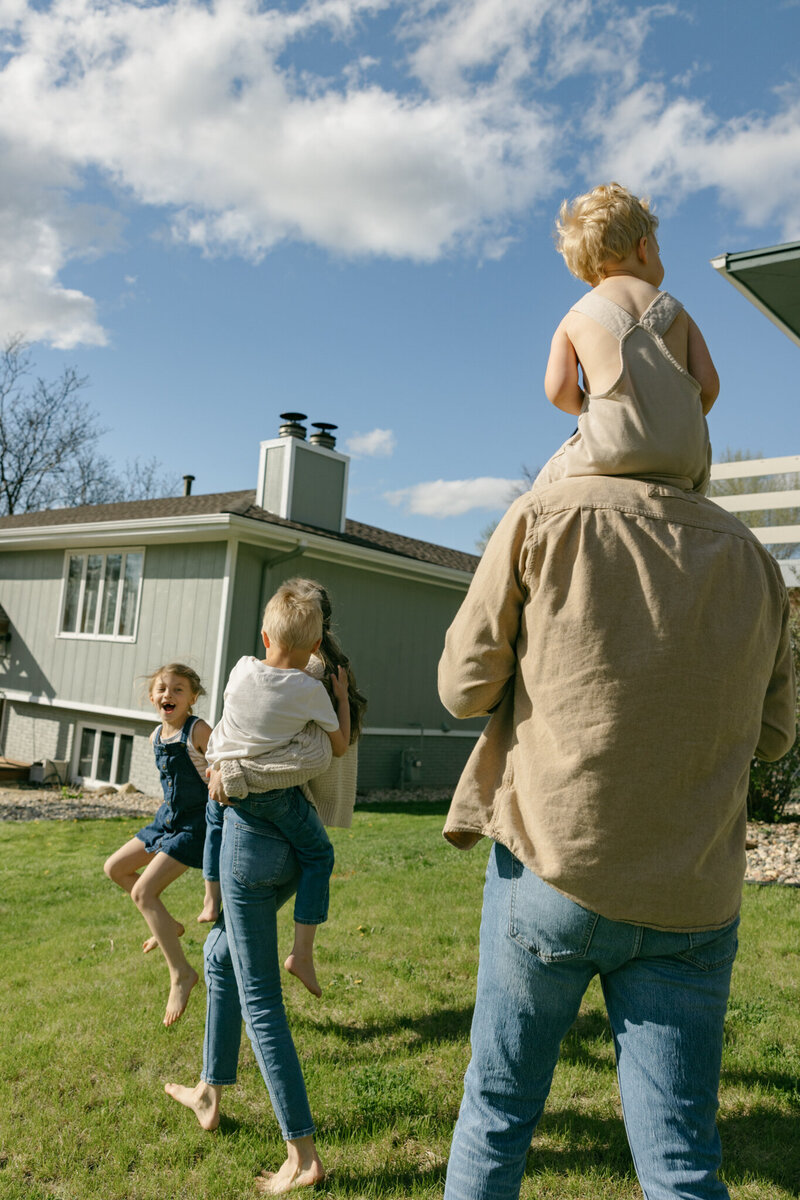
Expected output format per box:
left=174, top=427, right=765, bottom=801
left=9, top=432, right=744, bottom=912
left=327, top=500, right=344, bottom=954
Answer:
left=255, top=413, right=350, bottom=533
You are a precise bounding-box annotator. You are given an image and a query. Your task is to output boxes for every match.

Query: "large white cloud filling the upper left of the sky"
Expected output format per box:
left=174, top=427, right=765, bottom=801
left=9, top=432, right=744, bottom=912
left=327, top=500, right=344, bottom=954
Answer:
left=0, top=0, right=566, bottom=342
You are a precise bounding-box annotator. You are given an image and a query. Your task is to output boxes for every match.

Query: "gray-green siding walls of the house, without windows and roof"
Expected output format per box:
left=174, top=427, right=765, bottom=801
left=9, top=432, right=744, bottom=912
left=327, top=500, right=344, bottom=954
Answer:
left=0, top=532, right=483, bottom=792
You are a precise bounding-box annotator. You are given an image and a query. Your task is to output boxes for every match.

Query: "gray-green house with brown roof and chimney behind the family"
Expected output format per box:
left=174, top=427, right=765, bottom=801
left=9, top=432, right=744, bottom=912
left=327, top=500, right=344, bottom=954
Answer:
left=0, top=414, right=482, bottom=793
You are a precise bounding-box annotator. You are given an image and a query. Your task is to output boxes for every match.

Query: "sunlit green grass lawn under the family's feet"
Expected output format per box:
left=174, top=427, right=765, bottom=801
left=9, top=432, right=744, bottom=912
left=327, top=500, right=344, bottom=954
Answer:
left=0, top=805, right=800, bottom=1200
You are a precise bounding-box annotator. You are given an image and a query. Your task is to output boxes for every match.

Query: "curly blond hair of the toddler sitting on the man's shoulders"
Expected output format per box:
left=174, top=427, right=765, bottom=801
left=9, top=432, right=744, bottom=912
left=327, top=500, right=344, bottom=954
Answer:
left=555, top=184, right=658, bottom=287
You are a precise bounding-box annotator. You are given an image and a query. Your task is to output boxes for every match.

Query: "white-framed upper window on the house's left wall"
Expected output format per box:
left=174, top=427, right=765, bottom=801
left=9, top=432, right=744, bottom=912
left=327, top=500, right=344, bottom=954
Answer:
left=59, top=550, right=144, bottom=641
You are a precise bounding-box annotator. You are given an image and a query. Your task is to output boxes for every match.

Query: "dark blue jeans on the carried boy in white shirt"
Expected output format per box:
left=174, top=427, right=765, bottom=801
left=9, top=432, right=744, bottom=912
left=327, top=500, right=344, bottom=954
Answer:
left=203, top=787, right=333, bottom=925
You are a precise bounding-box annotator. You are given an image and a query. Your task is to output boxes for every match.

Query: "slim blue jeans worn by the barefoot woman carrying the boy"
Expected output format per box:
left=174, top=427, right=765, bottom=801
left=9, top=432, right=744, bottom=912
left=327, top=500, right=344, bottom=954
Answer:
left=203, top=793, right=314, bottom=1141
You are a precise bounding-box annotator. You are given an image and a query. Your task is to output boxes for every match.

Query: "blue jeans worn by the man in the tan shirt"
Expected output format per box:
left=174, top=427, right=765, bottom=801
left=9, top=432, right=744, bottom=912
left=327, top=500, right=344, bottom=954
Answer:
left=445, top=845, right=739, bottom=1200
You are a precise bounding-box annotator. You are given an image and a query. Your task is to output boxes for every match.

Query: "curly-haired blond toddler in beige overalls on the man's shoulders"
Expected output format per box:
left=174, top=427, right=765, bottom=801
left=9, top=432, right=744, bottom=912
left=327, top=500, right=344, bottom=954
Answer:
left=534, top=176, right=720, bottom=492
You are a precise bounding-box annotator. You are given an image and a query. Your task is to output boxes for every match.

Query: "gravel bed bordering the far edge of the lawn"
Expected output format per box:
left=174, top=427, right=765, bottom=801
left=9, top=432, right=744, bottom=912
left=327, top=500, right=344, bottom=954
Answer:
left=0, top=785, right=800, bottom=887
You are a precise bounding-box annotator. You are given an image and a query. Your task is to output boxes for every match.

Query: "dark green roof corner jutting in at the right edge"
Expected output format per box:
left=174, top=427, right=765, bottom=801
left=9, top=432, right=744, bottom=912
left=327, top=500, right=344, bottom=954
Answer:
left=711, top=241, right=800, bottom=346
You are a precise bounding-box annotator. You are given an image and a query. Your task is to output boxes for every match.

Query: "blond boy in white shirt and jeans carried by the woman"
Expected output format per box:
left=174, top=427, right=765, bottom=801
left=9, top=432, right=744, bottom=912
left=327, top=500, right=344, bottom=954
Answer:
left=203, top=581, right=350, bottom=996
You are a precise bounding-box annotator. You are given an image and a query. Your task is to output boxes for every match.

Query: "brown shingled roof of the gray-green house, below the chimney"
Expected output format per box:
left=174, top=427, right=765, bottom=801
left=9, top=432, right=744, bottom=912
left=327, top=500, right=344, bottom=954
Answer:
left=0, top=488, right=479, bottom=572
